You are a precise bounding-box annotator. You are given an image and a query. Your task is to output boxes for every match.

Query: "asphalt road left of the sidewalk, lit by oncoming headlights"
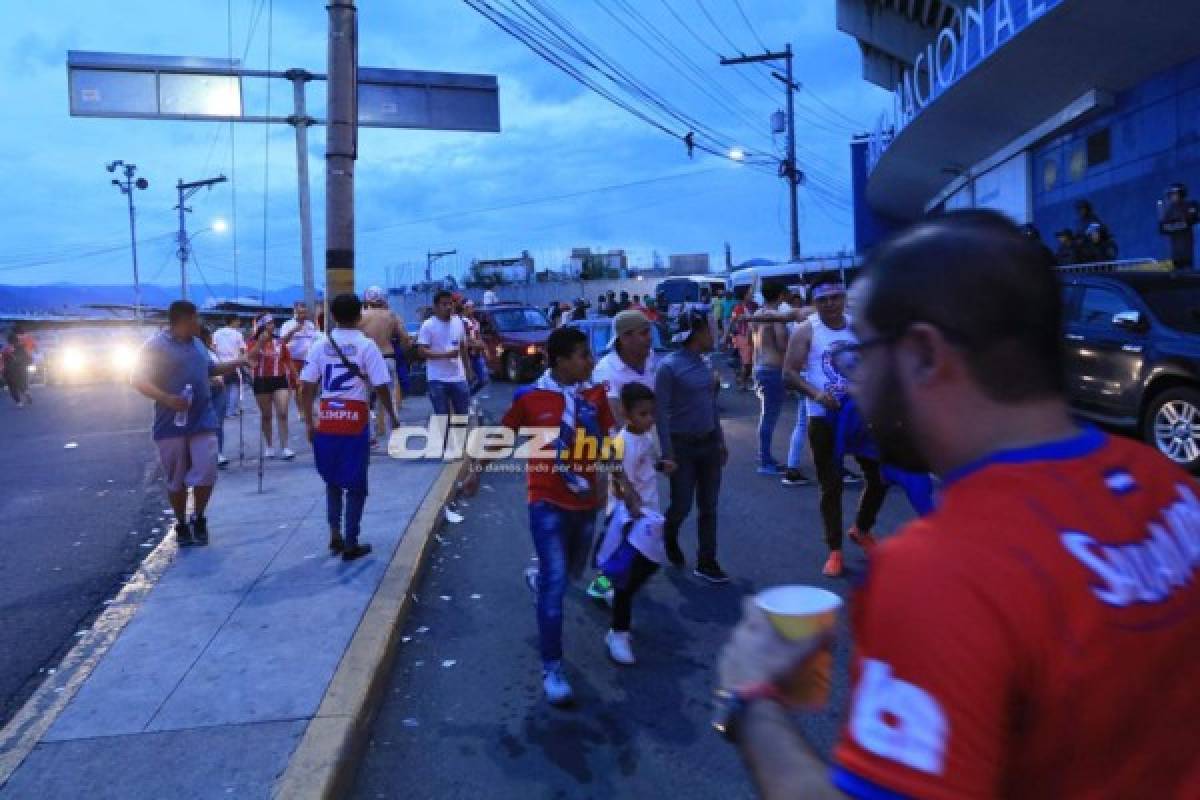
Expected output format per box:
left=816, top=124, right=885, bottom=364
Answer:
left=0, top=385, right=166, bottom=724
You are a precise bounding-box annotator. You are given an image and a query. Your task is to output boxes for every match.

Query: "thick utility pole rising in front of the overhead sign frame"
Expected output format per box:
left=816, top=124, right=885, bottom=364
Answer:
left=325, top=0, right=359, bottom=302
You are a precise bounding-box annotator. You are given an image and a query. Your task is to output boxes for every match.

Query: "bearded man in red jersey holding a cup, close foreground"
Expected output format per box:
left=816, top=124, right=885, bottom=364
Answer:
left=719, top=211, right=1200, bottom=799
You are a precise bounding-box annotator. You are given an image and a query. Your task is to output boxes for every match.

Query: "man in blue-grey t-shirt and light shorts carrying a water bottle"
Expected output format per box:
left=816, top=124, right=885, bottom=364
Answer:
left=133, top=300, right=247, bottom=547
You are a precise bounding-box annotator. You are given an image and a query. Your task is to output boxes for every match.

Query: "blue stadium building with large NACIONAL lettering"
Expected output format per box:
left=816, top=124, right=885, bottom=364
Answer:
left=838, top=0, right=1200, bottom=259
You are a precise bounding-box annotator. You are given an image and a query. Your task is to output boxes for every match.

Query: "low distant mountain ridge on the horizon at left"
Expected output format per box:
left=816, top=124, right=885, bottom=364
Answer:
left=0, top=283, right=314, bottom=313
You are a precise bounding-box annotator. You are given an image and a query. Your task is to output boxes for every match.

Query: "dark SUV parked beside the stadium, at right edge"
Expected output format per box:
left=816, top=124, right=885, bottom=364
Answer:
left=1062, top=269, right=1200, bottom=470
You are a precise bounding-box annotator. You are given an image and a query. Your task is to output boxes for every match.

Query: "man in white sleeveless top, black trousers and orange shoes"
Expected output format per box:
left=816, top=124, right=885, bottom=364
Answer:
left=784, top=278, right=887, bottom=578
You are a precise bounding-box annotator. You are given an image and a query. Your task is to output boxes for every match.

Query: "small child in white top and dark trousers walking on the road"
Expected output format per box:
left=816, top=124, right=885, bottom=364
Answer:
left=596, top=383, right=676, bottom=664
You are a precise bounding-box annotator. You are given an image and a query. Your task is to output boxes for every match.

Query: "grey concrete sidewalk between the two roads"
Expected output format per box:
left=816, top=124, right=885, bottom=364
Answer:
left=0, top=397, right=455, bottom=800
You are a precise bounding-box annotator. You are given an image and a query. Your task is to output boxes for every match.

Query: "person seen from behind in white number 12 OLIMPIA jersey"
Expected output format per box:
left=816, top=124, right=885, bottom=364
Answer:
left=300, top=294, right=400, bottom=561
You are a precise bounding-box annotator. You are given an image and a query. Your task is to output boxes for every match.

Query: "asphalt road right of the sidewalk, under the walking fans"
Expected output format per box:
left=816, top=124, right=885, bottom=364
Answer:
left=355, top=376, right=910, bottom=800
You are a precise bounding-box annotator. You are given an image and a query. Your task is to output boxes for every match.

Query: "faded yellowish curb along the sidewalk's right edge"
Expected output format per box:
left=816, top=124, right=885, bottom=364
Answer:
left=272, top=462, right=467, bottom=800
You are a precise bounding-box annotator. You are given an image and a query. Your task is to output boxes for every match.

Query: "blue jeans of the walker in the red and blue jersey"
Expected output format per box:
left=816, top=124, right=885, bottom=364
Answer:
left=529, top=501, right=596, bottom=666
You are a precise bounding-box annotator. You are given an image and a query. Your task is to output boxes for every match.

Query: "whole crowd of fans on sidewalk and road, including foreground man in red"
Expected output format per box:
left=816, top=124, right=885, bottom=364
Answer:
left=112, top=212, right=1200, bottom=798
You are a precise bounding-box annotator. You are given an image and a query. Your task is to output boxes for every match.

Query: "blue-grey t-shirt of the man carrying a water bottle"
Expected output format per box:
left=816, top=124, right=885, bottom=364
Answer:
left=137, top=331, right=217, bottom=439
